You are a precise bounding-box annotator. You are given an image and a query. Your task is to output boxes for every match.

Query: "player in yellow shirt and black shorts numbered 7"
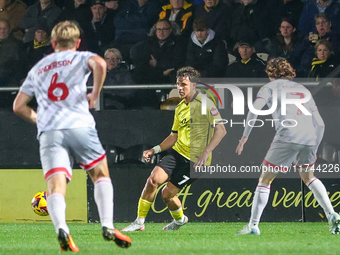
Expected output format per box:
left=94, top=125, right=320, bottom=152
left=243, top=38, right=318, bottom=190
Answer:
left=122, top=67, right=227, bottom=232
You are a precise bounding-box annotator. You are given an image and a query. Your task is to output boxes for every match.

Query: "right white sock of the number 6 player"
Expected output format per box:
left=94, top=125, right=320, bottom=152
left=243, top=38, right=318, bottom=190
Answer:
left=94, top=177, right=114, bottom=229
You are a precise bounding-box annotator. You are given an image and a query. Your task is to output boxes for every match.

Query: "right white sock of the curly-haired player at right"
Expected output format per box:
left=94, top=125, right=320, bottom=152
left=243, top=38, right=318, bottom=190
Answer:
left=306, top=177, right=334, bottom=218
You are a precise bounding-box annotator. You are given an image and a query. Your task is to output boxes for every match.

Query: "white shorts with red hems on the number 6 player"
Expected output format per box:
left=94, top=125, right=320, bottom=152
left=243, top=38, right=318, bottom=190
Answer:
left=39, top=128, right=106, bottom=181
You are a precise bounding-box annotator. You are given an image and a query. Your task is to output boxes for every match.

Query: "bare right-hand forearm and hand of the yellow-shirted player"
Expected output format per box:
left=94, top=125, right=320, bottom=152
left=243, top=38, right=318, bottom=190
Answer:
left=194, top=124, right=227, bottom=168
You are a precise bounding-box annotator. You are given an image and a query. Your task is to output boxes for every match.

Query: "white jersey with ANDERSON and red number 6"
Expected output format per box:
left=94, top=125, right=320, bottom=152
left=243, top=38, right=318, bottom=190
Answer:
left=20, top=51, right=95, bottom=136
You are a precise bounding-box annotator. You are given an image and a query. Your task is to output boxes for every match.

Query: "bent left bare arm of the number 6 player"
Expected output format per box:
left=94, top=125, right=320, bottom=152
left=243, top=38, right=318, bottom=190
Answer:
left=13, top=92, right=37, bottom=124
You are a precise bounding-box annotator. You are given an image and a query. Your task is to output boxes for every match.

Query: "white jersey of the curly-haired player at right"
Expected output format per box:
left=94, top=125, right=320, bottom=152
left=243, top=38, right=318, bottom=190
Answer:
left=257, top=79, right=318, bottom=145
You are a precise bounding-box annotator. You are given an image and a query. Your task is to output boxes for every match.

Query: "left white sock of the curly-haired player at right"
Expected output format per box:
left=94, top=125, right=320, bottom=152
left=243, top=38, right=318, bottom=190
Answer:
left=249, top=183, right=270, bottom=226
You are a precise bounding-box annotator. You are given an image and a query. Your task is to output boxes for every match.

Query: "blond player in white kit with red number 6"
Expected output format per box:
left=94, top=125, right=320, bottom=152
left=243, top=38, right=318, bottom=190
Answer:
left=13, top=21, right=131, bottom=252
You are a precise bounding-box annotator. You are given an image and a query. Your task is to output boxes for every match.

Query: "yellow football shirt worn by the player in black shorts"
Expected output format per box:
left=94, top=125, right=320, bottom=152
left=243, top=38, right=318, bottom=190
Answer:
left=172, top=92, right=222, bottom=165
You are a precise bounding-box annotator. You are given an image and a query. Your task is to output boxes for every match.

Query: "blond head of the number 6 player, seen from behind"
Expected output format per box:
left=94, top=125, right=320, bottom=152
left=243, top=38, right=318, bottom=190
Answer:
left=51, top=20, right=80, bottom=49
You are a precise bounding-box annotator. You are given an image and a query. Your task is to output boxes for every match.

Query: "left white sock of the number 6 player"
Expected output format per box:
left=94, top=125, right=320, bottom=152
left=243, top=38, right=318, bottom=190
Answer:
left=47, top=193, right=70, bottom=234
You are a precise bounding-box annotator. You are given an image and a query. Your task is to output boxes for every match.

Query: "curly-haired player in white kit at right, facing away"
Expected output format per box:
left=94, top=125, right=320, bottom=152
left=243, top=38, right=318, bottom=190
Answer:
left=236, top=58, right=340, bottom=235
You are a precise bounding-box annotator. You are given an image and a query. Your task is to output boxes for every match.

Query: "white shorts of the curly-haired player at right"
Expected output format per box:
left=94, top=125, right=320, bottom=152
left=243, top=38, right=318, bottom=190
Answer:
left=262, top=141, right=316, bottom=172
